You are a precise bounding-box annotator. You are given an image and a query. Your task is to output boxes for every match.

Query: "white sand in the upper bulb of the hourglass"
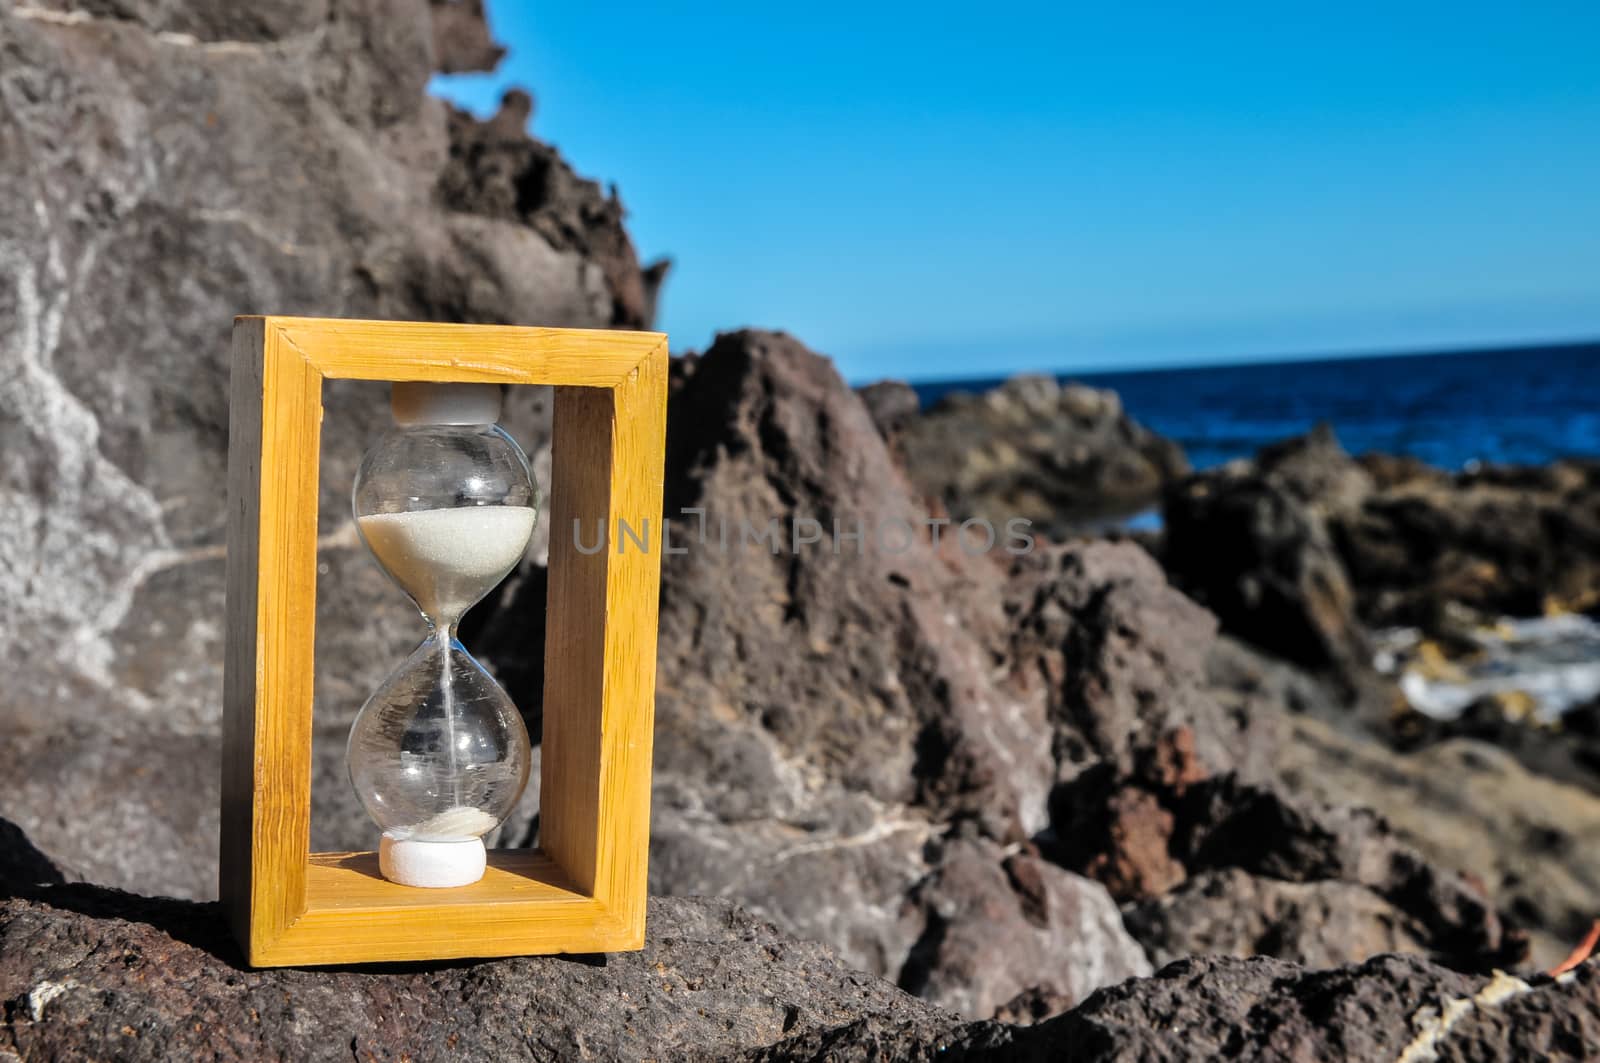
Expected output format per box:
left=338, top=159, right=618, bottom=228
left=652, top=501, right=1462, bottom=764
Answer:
left=358, top=506, right=534, bottom=626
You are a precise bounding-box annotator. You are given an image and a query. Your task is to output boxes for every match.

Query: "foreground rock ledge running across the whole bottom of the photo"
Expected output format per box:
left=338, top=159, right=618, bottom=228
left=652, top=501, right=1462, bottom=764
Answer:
left=0, top=821, right=1600, bottom=1063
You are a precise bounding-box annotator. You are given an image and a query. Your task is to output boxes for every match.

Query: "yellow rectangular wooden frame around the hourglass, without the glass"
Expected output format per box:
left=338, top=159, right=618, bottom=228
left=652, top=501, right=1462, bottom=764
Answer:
left=221, top=317, right=667, bottom=967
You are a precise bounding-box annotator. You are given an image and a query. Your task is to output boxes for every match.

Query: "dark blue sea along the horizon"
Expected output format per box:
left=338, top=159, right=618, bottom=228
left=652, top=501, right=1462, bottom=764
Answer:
left=914, top=343, right=1600, bottom=471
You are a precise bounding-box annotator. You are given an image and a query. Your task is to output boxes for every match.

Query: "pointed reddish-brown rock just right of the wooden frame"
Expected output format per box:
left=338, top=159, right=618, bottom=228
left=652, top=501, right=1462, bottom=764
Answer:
left=658, top=331, right=1051, bottom=840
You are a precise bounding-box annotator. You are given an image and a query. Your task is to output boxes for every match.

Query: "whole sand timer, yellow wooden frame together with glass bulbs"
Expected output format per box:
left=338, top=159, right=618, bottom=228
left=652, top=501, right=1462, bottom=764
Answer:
left=218, top=317, right=667, bottom=967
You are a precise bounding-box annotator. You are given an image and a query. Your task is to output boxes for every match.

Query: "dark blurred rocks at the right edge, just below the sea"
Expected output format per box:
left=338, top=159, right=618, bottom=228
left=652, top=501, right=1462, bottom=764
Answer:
left=1163, top=426, right=1600, bottom=671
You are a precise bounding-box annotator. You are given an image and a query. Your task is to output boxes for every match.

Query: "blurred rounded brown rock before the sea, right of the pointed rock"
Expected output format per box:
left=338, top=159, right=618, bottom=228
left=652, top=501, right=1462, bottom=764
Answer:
left=902, top=376, right=1189, bottom=540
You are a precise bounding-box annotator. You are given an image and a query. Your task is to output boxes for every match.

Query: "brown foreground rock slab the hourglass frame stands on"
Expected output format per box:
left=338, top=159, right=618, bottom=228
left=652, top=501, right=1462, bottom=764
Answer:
left=0, top=885, right=957, bottom=1061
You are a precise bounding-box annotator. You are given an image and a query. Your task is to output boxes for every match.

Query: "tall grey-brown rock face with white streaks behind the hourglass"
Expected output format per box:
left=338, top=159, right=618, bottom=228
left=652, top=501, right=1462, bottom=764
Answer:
left=0, top=0, right=659, bottom=897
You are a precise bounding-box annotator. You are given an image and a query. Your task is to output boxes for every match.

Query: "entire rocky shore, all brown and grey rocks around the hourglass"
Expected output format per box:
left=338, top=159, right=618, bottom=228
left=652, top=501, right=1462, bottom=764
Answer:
left=0, top=0, right=1600, bottom=1060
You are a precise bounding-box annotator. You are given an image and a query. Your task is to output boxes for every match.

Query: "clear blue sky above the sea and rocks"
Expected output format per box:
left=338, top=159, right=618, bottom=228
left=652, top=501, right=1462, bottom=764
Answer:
left=435, top=0, right=1600, bottom=381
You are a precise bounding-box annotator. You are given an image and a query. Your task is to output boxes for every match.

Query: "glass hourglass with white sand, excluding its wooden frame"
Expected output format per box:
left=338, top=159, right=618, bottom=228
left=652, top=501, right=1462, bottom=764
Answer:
left=347, top=383, right=538, bottom=887
